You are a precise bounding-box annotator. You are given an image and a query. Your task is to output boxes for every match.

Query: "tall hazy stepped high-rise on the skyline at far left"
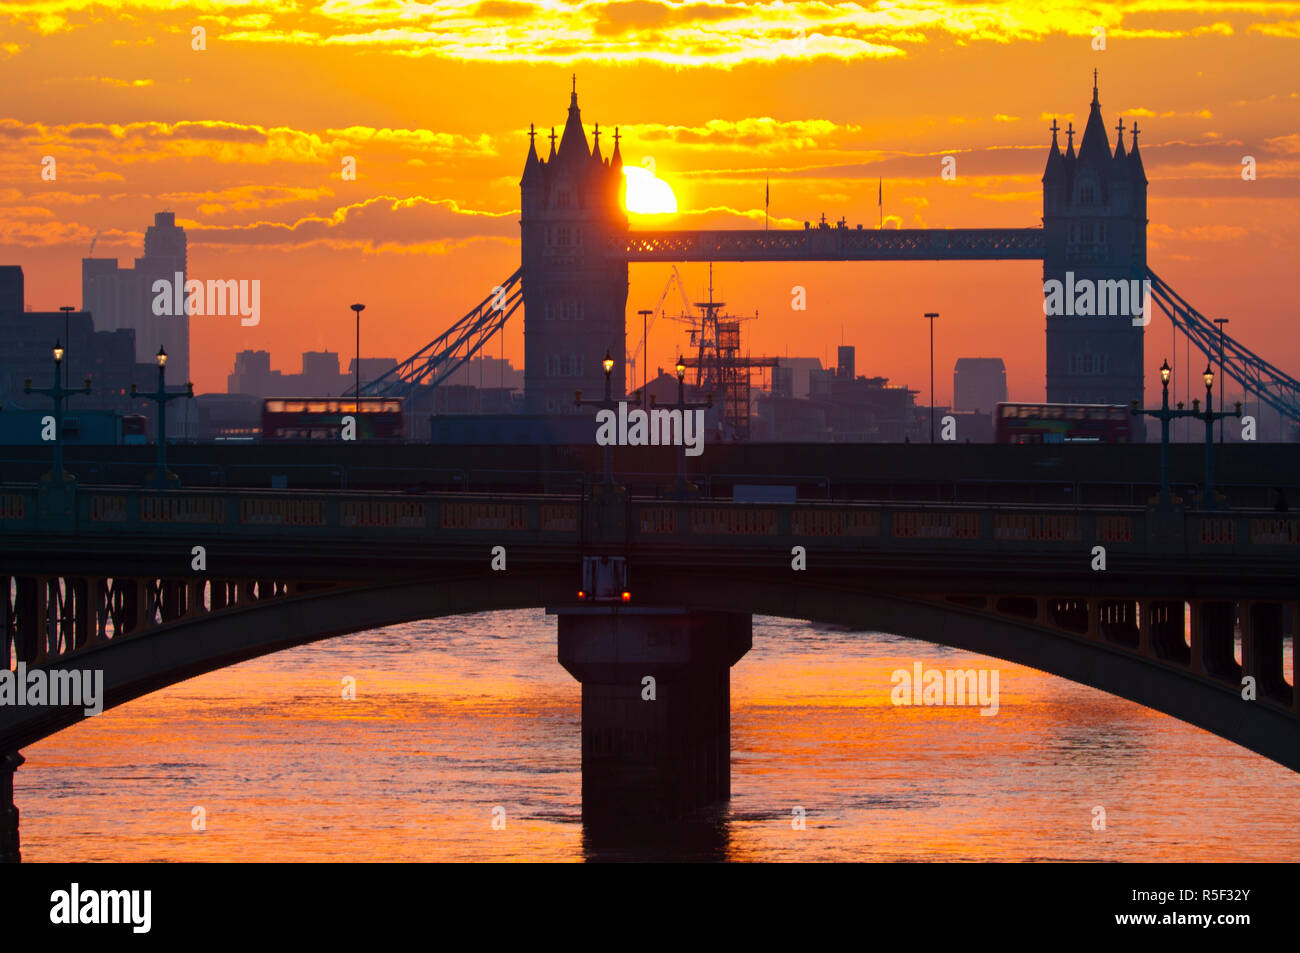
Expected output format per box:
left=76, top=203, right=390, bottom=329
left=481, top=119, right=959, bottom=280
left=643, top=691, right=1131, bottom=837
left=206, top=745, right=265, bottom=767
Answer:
left=82, top=212, right=190, bottom=395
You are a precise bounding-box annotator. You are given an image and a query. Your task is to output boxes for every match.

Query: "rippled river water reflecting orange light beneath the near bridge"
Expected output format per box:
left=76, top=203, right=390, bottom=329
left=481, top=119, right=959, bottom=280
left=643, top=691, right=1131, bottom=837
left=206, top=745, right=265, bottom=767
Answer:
left=14, top=610, right=1300, bottom=861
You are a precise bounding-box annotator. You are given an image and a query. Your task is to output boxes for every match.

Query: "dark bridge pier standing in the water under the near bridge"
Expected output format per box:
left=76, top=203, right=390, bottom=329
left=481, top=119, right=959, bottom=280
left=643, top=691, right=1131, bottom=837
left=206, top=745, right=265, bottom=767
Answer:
left=559, top=607, right=751, bottom=831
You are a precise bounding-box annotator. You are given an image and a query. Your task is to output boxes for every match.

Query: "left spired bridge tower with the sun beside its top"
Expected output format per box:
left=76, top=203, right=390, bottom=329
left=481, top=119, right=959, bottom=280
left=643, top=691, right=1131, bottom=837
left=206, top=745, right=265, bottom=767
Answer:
left=519, top=78, right=628, bottom=413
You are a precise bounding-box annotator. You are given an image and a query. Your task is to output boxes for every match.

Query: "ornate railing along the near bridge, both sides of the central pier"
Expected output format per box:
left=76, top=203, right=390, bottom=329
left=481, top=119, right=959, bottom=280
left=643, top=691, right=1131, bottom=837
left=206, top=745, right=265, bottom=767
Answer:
left=0, top=486, right=1300, bottom=556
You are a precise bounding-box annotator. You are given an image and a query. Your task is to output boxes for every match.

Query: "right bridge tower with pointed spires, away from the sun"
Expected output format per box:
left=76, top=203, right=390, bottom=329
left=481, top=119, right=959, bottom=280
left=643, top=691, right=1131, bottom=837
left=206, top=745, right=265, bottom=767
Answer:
left=1043, top=70, right=1149, bottom=439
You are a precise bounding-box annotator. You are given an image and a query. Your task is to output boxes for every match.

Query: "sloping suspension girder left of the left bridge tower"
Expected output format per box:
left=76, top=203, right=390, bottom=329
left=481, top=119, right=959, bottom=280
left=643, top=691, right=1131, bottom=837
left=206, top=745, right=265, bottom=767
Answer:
left=361, top=268, right=524, bottom=397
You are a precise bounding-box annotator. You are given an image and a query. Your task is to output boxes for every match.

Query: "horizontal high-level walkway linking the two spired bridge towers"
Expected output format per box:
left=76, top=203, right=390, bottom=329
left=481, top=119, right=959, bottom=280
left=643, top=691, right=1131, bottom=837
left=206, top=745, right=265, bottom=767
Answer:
left=610, top=226, right=1045, bottom=261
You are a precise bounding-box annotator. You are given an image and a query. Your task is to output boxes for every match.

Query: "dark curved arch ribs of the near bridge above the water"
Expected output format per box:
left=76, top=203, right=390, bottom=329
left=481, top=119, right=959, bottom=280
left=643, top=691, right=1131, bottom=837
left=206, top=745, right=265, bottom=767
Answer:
left=0, top=568, right=1300, bottom=771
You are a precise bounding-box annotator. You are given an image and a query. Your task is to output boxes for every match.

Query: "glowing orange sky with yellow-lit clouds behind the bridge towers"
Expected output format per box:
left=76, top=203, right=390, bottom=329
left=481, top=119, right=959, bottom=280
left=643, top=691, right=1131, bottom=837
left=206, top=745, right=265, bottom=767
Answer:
left=0, top=0, right=1300, bottom=402
